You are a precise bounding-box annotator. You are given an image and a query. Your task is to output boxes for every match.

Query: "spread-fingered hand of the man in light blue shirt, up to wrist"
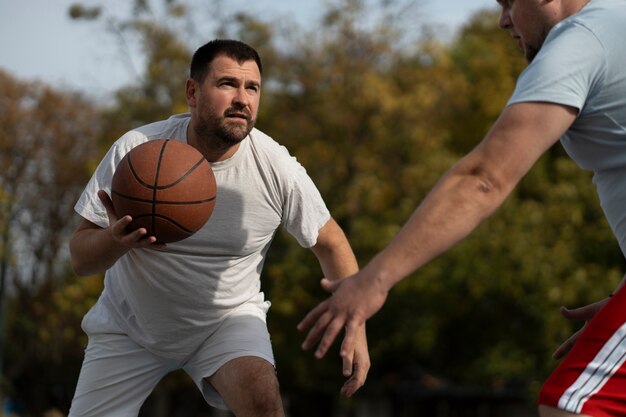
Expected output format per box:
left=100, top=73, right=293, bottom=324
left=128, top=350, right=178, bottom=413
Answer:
left=298, top=271, right=389, bottom=359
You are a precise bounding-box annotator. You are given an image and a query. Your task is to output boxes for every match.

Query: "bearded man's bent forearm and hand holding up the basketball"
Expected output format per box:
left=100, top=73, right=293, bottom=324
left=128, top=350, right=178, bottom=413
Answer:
left=70, top=191, right=163, bottom=275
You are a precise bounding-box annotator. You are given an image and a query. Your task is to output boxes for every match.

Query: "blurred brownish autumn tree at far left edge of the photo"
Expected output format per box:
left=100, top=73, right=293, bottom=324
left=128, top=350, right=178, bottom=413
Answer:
left=0, top=71, right=100, bottom=411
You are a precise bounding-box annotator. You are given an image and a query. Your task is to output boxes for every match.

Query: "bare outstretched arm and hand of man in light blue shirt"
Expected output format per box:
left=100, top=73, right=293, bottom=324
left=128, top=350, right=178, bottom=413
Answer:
left=298, top=103, right=577, bottom=357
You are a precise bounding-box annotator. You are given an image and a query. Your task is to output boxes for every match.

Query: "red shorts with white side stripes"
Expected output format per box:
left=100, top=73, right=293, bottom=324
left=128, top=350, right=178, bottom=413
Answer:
left=538, top=287, right=626, bottom=417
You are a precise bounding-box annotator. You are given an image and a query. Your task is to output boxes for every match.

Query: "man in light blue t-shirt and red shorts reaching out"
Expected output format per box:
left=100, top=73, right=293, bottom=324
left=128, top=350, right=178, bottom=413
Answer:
left=298, top=0, right=626, bottom=417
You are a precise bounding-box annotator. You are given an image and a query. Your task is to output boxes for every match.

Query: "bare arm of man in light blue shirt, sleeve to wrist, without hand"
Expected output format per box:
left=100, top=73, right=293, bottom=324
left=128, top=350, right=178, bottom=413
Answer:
left=365, top=103, right=577, bottom=289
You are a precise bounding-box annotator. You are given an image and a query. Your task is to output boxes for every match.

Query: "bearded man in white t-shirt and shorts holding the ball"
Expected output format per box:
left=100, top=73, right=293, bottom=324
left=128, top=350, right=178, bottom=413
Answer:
left=70, top=40, right=369, bottom=417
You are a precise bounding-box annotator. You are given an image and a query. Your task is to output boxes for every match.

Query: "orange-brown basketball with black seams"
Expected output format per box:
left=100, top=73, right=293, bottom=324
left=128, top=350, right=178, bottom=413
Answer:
left=111, top=139, right=217, bottom=243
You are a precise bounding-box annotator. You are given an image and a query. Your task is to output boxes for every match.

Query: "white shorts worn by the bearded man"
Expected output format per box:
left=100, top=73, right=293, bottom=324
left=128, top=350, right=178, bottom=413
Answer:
left=68, top=300, right=275, bottom=417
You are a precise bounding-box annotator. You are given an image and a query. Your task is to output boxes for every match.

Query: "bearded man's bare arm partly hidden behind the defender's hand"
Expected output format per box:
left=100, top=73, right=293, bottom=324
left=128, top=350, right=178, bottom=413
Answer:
left=311, top=219, right=370, bottom=397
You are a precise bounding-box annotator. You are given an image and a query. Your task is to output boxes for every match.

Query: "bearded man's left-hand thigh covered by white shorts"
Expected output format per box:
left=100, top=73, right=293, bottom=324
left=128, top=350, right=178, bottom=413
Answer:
left=69, top=333, right=176, bottom=417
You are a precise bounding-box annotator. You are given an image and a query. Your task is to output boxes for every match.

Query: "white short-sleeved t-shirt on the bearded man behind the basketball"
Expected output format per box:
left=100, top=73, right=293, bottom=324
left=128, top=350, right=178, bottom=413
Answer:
left=75, top=114, right=330, bottom=359
